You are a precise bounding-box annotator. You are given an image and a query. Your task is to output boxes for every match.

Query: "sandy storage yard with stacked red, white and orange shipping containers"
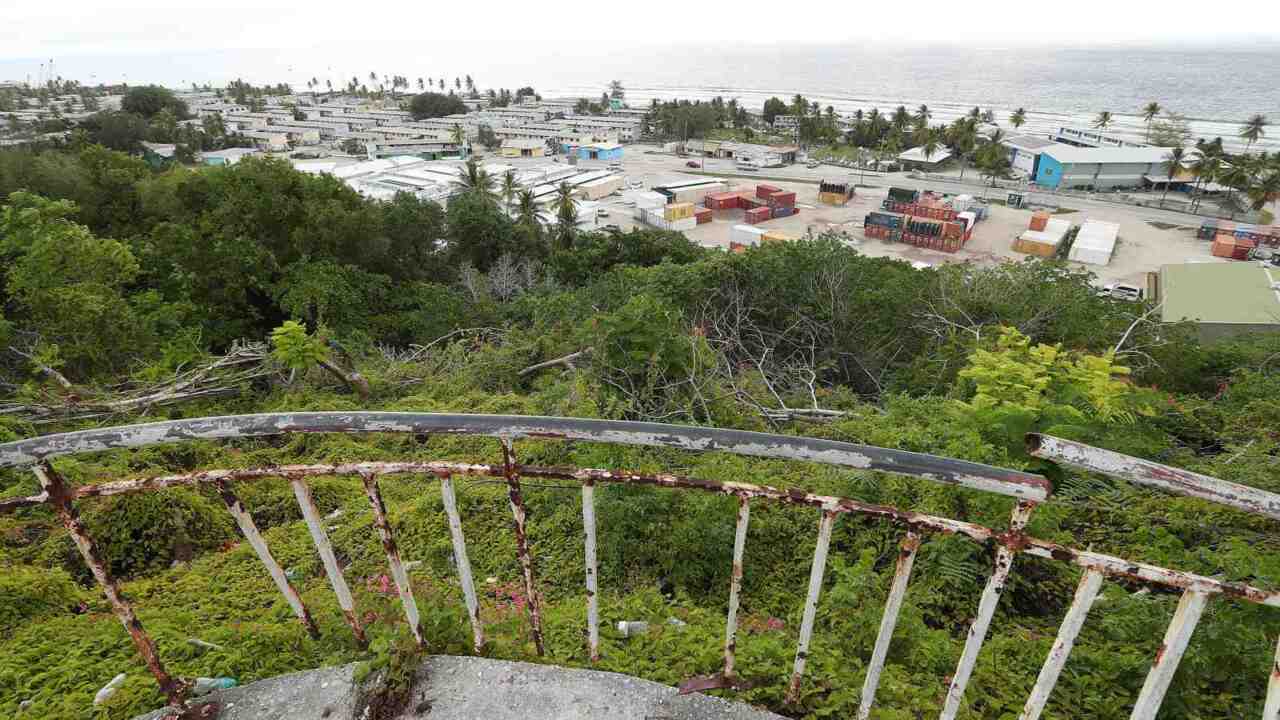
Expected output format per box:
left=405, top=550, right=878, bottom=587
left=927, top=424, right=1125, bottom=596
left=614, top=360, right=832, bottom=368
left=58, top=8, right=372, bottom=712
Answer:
left=432, top=144, right=1280, bottom=287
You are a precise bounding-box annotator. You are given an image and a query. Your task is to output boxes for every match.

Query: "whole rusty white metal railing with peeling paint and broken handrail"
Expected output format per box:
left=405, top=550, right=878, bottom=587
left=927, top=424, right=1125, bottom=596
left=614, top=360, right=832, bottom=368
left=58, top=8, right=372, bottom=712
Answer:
left=0, top=413, right=1280, bottom=720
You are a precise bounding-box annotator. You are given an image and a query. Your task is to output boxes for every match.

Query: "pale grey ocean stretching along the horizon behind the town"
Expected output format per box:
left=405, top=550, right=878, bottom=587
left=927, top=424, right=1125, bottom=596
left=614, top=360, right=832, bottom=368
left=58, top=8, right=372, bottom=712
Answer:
left=0, top=44, right=1280, bottom=151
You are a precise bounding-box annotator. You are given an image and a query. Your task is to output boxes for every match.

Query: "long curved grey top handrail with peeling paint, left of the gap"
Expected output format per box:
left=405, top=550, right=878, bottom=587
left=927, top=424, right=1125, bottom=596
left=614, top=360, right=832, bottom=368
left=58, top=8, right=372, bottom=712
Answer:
left=0, top=411, right=1052, bottom=502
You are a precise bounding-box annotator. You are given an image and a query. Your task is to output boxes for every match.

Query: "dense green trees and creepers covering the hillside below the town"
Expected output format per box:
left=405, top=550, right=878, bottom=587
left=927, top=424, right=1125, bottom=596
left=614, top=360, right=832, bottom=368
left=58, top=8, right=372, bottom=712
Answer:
left=0, top=141, right=1280, bottom=720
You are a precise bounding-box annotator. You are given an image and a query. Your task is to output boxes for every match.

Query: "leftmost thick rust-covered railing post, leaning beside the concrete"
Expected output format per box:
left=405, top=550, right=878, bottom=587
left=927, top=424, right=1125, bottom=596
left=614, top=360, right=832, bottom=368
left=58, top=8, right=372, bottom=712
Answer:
left=32, top=462, right=191, bottom=707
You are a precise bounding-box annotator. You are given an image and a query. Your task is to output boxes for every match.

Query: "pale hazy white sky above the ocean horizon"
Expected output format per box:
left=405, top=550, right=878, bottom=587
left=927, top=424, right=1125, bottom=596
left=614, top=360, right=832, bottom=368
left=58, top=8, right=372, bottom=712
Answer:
left=10, top=0, right=1280, bottom=64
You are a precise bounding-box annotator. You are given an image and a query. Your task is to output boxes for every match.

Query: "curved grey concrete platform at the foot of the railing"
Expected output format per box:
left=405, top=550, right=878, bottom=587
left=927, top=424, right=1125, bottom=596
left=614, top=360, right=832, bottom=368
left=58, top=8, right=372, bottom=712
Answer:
left=136, top=656, right=783, bottom=720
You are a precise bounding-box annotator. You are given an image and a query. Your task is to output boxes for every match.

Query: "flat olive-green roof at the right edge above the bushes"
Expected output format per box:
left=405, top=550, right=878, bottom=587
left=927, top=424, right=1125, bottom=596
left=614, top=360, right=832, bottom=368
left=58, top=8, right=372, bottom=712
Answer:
left=1160, top=261, right=1280, bottom=325
